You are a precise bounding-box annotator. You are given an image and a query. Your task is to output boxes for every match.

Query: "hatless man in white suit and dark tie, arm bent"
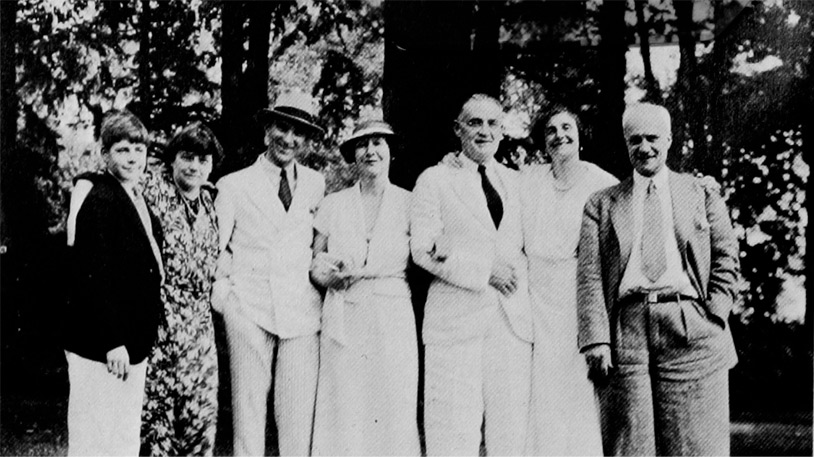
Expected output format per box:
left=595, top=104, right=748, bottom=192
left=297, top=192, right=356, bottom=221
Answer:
left=410, top=94, right=532, bottom=455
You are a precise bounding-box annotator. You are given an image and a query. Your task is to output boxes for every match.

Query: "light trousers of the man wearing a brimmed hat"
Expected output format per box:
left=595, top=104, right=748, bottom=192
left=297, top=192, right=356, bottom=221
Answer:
left=224, top=310, right=326, bottom=456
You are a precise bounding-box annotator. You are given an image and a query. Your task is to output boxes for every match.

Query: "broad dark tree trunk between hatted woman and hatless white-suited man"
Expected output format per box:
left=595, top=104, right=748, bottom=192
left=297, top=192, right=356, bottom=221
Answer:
left=383, top=0, right=474, bottom=189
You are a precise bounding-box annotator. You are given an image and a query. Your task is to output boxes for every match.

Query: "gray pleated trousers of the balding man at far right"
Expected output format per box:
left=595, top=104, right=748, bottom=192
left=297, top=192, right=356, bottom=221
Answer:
left=598, top=300, right=729, bottom=455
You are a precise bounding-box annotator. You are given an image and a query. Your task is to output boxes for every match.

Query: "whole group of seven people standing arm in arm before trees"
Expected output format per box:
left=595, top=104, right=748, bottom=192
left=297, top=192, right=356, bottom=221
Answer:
left=65, top=86, right=738, bottom=455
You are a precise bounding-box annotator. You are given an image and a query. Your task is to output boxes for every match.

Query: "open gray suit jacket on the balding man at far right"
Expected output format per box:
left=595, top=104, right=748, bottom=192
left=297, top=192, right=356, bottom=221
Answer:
left=577, top=171, right=739, bottom=372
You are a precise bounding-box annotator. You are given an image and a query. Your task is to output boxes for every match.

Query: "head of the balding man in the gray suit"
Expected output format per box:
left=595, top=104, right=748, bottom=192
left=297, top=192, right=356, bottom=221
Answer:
left=622, top=103, right=673, bottom=177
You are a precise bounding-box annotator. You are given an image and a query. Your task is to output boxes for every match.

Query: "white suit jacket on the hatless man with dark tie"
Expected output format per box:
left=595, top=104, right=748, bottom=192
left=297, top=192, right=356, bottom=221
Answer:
left=410, top=160, right=533, bottom=344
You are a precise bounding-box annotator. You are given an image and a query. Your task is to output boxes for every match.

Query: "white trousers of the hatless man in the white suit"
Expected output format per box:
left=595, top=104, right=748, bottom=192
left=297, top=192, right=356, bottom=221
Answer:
left=424, top=309, right=531, bottom=455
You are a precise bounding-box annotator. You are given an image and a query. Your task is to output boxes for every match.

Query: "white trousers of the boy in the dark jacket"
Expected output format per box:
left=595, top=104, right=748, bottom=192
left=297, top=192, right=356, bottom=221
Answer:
left=65, top=351, right=147, bottom=456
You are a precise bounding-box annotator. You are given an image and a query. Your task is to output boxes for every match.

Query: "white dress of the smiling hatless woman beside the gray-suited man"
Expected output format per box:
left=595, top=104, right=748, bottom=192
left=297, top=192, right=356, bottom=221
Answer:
left=521, top=162, right=617, bottom=455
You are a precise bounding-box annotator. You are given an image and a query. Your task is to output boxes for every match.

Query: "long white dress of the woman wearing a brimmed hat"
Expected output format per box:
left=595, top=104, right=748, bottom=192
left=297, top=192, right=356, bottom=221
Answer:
left=312, top=184, right=421, bottom=455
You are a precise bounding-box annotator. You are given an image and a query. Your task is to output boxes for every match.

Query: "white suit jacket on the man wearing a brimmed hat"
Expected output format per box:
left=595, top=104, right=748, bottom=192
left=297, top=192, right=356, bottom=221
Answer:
left=213, top=155, right=325, bottom=338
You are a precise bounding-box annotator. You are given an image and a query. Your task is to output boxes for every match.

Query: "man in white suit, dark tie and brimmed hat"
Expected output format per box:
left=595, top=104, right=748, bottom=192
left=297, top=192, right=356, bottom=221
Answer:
left=212, top=92, right=325, bottom=455
